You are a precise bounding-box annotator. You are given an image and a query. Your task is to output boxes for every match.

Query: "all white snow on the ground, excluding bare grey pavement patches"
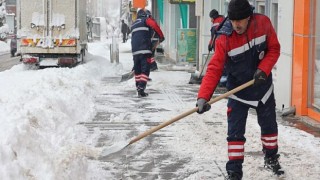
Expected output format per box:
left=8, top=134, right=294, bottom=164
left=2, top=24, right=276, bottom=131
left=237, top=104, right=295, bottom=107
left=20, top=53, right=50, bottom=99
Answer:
left=0, top=37, right=320, bottom=180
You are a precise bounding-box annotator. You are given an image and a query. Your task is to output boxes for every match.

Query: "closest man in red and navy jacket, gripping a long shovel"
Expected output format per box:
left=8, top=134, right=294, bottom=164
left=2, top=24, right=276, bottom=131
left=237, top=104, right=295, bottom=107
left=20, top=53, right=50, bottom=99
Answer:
left=196, top=0, right=284, bottom=179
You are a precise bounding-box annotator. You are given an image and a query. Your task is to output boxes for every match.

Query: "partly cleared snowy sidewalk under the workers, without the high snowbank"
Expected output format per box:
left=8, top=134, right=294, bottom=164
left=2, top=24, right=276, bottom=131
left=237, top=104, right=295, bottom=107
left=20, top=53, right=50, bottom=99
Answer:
left=84, top=41, right=320, bottom=180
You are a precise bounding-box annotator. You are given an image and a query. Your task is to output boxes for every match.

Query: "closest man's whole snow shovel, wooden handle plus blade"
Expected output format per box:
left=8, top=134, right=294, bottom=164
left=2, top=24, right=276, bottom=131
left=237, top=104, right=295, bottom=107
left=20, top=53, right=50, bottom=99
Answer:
left=100, top=79, right=254, bottom=157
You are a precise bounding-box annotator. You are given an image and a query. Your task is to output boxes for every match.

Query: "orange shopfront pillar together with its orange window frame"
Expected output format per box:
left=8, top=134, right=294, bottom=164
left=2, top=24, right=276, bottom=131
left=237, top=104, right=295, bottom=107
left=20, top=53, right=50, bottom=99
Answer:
left=291, top=0, right=320, bottom=121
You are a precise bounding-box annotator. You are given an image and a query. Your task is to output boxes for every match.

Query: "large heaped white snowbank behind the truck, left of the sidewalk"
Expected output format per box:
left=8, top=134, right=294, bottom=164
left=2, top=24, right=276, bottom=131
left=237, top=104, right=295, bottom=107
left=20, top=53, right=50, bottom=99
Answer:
left=0, top=41, right=117, bottom=179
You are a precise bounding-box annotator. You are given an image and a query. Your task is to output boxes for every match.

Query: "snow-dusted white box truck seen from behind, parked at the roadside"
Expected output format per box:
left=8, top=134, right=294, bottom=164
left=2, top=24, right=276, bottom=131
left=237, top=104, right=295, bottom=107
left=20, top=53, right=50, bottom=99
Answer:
left=17, top=0, right=87, bottom=68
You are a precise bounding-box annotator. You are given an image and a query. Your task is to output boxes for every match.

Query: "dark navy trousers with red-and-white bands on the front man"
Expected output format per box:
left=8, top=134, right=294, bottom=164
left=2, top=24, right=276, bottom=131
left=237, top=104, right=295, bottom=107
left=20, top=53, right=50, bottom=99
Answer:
left=226, top=93, right=278, bottom=175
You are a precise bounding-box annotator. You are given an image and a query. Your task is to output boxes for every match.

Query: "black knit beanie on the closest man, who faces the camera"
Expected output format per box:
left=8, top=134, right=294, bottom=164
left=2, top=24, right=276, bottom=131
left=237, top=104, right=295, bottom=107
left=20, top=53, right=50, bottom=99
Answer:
left=228, top=0, right=253, bottom=20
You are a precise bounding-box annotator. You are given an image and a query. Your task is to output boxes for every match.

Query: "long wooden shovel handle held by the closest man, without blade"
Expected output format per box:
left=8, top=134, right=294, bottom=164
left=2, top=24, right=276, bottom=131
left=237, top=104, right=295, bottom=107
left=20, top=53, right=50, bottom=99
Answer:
left=128, top=80, right=254, bottom=145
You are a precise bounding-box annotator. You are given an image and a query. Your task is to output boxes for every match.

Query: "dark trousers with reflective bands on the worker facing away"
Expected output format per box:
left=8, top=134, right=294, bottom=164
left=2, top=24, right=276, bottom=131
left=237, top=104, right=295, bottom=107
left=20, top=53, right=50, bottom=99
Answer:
left=133, top=54, right=151, bottom=91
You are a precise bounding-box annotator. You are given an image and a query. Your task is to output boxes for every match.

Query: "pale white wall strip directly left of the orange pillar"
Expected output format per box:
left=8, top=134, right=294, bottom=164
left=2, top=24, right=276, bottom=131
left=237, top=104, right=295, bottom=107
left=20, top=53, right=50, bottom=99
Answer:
left=273, top=0, right=294, bottom=110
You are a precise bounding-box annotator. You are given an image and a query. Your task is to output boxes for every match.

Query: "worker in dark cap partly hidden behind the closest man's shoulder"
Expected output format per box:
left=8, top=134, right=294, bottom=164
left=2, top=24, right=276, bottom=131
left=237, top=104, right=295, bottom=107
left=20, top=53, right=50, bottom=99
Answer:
left=208, top=9, right=224, bottom=52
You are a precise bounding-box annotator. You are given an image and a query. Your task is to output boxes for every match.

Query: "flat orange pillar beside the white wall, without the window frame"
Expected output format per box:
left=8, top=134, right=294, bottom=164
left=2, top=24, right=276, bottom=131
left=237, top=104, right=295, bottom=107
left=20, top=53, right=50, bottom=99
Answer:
left=292, top=0, right=310, bottom=116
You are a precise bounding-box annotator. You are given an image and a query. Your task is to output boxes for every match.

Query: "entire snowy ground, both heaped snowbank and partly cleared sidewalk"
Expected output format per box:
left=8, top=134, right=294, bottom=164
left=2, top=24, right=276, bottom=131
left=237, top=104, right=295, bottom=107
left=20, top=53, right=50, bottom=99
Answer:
left=0, top=41, right=320, bottom=180
